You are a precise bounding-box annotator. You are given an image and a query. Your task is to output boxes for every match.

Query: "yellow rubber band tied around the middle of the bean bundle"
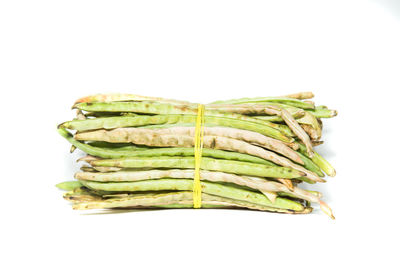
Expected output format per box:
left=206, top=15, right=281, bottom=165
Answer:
left=193, top=104, right=204, bottom=209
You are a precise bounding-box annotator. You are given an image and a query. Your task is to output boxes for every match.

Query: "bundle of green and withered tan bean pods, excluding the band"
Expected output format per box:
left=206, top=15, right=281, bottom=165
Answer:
left=57, top=92, right=337, bottom=218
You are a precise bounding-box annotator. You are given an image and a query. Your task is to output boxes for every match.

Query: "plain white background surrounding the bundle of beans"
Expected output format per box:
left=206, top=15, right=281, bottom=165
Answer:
left=0, top=0, right=400, bottom=267
